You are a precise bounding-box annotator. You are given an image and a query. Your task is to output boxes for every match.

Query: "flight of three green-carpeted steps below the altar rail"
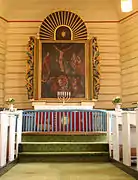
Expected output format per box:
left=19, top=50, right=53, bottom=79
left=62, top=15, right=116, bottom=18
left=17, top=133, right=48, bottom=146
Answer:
left=19, top=133, right=109, bottom=162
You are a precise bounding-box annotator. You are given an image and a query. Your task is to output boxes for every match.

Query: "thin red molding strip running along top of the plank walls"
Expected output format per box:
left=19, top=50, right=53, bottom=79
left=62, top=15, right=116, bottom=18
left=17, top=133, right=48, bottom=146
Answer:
left=0, top=10, right=138, bottom=24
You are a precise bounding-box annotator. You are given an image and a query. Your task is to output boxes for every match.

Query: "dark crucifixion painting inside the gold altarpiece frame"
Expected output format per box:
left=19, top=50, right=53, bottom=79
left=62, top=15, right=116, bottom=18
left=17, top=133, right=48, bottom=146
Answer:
left=39, top=41, right=86, bottom=99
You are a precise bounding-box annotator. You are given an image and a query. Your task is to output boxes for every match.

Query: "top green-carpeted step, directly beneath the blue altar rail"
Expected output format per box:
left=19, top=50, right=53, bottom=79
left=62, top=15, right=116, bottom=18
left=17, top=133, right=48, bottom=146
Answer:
left=22, top=132, right=107, bottom=142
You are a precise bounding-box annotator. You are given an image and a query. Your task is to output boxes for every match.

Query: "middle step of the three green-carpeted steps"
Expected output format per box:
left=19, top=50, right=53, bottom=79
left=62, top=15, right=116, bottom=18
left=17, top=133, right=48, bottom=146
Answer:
left=19, top=142, right=109, bottom=152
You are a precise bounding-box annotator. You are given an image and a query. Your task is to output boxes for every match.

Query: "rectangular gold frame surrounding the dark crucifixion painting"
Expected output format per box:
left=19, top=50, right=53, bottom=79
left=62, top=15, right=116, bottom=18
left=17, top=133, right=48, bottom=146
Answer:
left=34, top=40, right=92, bottom=102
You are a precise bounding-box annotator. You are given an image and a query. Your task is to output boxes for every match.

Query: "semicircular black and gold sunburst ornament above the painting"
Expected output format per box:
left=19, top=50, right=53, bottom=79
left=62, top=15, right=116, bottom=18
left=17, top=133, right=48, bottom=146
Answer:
left=39, top=11, right=87, bottom=40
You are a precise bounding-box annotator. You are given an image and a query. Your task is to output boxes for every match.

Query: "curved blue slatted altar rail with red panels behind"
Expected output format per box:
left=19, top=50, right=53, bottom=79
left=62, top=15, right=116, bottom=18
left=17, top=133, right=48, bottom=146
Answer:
left=22, top=109, right=107, bottom=132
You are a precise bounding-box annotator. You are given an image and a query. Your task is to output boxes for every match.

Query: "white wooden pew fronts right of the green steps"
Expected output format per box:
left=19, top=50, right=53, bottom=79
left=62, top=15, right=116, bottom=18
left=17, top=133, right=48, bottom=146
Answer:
left=108, top=109, right=138, bottom=169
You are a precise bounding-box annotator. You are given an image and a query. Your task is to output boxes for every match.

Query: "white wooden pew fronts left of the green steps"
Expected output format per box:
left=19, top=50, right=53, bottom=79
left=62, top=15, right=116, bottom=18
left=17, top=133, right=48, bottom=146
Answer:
left=0, top=111, right=22, bottom=167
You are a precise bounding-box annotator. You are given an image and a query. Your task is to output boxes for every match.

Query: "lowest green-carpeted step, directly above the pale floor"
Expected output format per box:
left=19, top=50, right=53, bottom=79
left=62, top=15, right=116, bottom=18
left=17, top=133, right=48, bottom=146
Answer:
left=18, top=152, right=109, bottom=163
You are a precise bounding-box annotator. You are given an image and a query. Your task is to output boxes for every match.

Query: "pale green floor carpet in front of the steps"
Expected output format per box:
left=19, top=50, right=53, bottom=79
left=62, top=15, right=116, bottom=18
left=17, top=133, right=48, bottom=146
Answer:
left=1, top=163, right=134, bottom=180
